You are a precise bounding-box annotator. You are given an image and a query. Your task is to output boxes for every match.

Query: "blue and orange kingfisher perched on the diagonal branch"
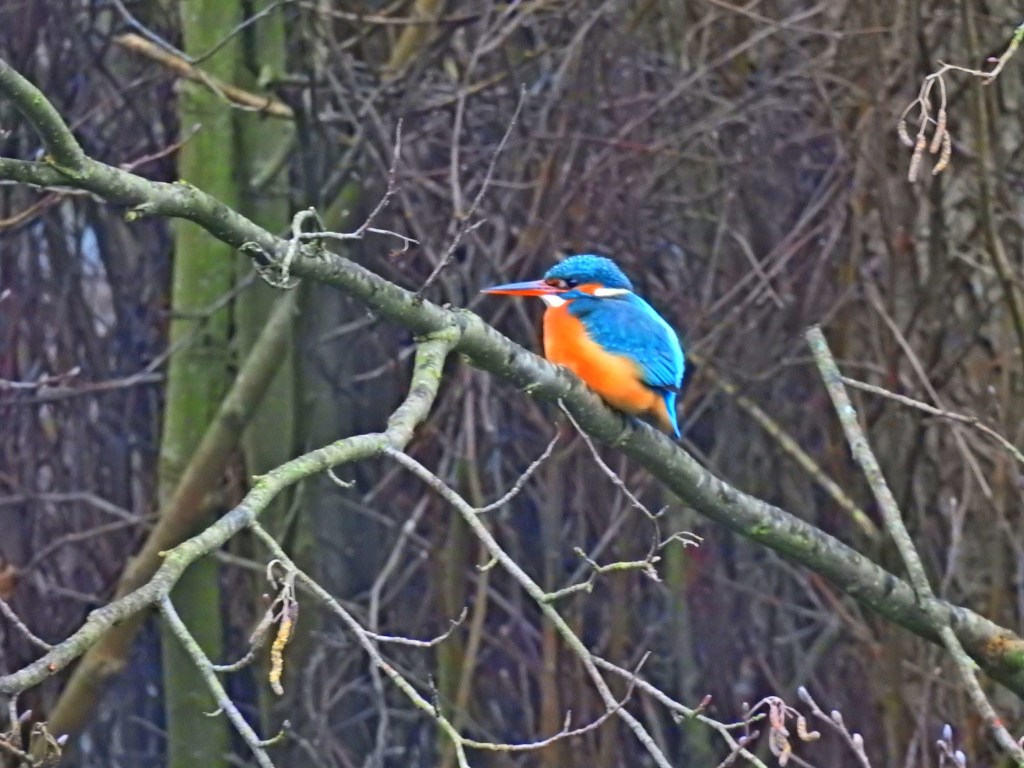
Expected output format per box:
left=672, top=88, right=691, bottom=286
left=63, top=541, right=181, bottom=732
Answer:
left=482, top=254, right=686, bottom=437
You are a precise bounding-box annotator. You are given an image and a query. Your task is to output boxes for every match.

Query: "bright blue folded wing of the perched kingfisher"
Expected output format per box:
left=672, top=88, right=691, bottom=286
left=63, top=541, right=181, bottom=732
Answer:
left=569, top=294, right=686, bottom=390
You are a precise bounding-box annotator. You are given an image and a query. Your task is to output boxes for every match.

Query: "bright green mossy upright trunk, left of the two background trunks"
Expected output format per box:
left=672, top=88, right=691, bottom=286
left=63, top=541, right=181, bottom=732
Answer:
left=159, top=0, right=241, bottom=768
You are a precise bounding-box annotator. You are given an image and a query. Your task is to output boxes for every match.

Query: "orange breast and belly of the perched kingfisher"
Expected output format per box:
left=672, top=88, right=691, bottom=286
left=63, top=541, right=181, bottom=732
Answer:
left=544, top=303, right=672, bottom=429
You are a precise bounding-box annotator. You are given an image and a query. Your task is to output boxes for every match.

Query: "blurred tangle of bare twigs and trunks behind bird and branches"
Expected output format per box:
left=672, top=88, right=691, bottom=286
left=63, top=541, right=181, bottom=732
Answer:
left=0, top=0, right=1024, bottom=768
